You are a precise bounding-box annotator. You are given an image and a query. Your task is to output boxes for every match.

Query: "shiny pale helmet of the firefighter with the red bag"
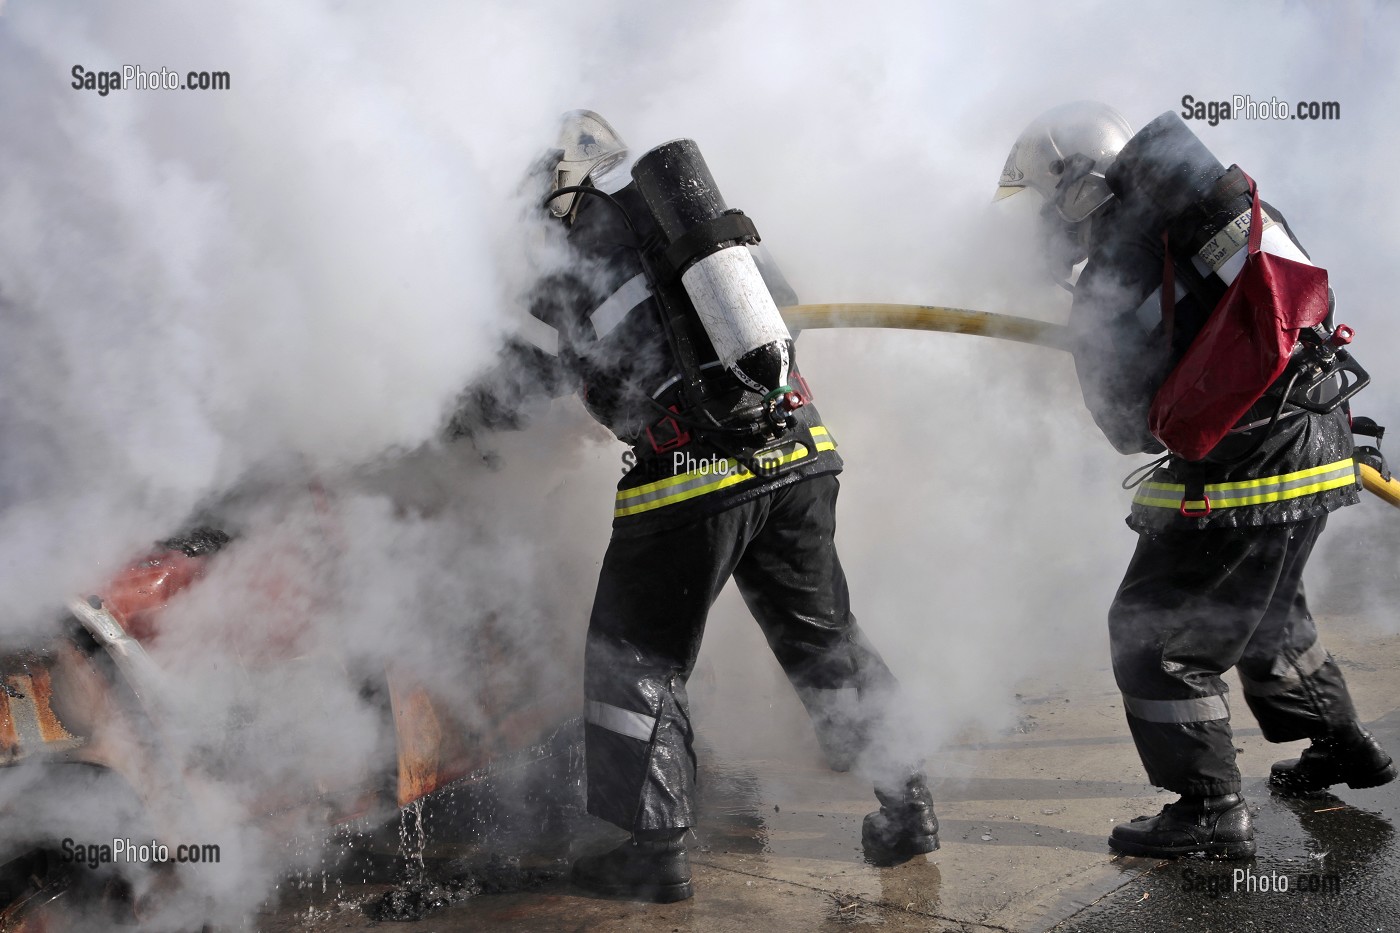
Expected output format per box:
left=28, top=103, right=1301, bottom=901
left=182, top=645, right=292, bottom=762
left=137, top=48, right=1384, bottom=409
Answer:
left=994, top=101, right=1133, bottom=224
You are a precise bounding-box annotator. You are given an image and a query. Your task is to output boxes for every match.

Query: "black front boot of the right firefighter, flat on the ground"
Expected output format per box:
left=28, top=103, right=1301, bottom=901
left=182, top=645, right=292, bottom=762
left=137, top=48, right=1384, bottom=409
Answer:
left=1109, top=794, right=1254, bottom=859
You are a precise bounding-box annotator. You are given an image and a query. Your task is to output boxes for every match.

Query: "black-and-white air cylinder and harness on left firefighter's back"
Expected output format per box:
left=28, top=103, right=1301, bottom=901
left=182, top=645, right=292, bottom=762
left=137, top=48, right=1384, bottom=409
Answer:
left=545, top=139, right=809, bottom=476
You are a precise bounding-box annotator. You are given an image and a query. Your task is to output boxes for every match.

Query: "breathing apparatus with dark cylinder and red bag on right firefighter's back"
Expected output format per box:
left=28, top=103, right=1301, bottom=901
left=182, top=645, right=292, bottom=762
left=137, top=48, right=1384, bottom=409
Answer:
left=1107, top=113, right=1371, bottom=473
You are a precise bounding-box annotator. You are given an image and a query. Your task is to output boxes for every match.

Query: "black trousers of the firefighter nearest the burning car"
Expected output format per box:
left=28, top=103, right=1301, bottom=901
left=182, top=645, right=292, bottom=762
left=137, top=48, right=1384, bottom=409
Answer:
left=584, top=474, right=911, bottom=831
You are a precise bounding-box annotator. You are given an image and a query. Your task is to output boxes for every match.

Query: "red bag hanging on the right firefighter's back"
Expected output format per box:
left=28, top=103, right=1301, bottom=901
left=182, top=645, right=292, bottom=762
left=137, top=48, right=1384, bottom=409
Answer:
left=1148, top=175, right=1327, bottom=461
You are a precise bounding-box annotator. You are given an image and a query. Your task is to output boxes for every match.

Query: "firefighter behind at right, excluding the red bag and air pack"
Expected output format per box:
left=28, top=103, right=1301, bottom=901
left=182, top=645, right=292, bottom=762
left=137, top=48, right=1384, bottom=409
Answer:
left=998, top=102, right=1396, bottom=857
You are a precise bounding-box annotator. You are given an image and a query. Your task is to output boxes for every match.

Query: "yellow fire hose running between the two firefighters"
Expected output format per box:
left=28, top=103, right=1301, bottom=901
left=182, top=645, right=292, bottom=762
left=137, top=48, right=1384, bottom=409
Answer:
left=781, top=304, right=1400, bottom=509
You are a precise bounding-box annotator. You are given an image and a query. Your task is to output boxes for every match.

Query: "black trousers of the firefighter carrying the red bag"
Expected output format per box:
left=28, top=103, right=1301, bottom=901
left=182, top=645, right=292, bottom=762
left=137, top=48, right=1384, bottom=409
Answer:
left=1109, top=516, right=1355, bottom=796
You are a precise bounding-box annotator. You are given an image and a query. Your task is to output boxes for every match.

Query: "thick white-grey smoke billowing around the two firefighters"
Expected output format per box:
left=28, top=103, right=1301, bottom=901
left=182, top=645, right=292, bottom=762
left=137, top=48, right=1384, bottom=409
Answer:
left=0, top=0, right=1400, bottom=913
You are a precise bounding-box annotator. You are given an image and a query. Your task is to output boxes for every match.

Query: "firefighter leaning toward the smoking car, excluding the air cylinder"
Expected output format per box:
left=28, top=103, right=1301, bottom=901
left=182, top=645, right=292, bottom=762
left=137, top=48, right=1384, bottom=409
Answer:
left=448, top=111, right=938, bottom=901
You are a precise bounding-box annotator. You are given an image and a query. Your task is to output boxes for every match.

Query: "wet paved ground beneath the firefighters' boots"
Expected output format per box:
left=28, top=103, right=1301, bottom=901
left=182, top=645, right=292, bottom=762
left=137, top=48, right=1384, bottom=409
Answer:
left=256, top=613, right=1400, bottom=933
